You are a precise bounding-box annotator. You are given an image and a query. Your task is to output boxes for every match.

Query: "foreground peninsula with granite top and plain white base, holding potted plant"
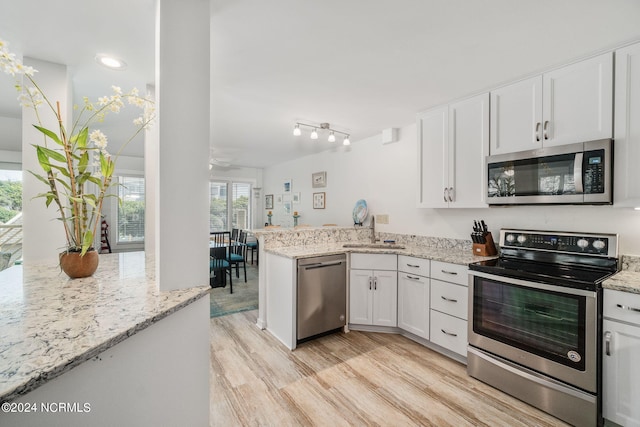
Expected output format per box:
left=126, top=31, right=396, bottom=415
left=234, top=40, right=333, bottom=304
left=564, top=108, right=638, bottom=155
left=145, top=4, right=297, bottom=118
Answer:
left=0, top=252, right=210, bottom=426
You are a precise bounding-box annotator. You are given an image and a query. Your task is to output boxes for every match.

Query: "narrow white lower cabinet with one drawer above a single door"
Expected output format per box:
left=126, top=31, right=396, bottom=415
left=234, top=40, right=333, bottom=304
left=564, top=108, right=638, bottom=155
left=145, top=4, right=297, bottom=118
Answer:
left=398, top=255, right=430, bottom=339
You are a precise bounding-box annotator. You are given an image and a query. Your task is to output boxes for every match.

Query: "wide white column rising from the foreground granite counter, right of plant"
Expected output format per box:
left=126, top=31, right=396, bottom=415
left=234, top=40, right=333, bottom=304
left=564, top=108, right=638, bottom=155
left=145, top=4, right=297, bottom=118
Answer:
left=155, top=0, right=210, bottom=291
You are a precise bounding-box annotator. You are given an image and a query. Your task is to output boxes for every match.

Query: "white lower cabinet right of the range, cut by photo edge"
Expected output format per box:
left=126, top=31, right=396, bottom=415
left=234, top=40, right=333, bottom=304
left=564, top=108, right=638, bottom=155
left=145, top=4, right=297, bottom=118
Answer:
left=602, top=289, right=640, bottom=427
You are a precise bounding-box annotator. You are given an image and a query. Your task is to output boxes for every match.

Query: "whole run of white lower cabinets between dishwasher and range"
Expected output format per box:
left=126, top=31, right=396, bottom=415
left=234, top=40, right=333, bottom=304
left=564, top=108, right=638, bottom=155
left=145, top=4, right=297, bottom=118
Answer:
left=349, top=254, right=468, bottom=360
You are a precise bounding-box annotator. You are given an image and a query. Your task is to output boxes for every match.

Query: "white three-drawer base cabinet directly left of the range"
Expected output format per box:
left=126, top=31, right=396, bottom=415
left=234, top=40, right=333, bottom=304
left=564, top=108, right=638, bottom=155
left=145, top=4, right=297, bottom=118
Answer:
left=429, top=261, right=468, bottom=357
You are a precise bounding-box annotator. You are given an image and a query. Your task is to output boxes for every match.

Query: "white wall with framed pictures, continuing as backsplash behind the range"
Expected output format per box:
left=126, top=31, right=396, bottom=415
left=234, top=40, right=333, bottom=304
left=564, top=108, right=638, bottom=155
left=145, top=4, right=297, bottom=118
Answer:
left=263, top=125, right=640, bottom=255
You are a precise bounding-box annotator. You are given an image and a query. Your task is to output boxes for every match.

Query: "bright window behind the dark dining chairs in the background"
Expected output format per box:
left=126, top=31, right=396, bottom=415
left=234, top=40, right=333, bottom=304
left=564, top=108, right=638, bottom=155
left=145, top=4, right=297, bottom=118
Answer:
left=209, top=181, right=251, bottom=231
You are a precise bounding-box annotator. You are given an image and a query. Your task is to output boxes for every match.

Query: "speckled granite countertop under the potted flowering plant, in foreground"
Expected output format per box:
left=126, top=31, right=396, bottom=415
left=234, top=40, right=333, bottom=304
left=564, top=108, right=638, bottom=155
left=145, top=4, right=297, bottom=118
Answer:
left=0, top=252, right=210, bottom=402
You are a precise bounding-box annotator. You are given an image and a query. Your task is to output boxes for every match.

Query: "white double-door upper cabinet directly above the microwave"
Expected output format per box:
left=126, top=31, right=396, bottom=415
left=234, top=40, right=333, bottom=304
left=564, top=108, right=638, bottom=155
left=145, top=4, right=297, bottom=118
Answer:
left=490, top=53, right=613, bottom=154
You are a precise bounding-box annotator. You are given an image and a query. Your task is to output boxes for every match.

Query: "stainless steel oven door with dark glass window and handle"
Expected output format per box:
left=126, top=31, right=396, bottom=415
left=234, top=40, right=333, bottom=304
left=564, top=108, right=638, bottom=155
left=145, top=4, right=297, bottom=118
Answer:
left=469, top=271, right=598, bottom=393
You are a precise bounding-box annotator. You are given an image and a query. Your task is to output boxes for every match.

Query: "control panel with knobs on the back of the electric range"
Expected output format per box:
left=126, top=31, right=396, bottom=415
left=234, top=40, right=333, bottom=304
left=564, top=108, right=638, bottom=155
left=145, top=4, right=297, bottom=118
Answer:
left=500, top=229, right=618, bottom=258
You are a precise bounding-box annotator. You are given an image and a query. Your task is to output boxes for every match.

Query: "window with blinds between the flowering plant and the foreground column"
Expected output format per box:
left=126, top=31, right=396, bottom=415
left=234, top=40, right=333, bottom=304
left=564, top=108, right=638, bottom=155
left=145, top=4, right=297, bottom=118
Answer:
left=118, top=176, right=144, bottom=243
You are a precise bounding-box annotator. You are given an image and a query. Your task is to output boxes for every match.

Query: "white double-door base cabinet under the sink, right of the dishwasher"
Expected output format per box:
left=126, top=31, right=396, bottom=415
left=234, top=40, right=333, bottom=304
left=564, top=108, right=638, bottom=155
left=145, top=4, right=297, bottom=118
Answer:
left=349, top=254, right=398, bottom=327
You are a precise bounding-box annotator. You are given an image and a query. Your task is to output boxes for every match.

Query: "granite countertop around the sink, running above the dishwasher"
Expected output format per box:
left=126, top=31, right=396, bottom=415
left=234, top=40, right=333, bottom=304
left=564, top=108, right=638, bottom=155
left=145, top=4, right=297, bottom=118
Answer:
left=265, top=242, right=496, bottom=265
